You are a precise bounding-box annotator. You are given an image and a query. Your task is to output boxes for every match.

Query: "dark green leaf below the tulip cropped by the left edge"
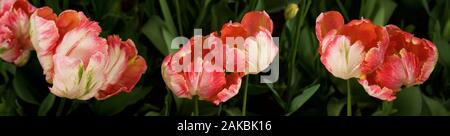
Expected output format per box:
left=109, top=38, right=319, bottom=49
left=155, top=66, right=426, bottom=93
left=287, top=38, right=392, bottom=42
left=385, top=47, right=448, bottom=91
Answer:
left=13, top=71, right=39, bottom=105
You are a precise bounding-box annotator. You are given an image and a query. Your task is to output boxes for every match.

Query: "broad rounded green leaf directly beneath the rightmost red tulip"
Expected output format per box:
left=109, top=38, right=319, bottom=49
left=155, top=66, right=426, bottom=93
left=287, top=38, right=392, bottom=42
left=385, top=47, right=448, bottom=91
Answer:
left=393, top=87, right=422, bottom=116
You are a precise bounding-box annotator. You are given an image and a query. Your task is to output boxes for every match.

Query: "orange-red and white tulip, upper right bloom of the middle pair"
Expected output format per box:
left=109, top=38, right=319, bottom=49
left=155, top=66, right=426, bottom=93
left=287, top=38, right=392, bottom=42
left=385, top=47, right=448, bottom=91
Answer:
left=220, top=11, right=278, bottom=74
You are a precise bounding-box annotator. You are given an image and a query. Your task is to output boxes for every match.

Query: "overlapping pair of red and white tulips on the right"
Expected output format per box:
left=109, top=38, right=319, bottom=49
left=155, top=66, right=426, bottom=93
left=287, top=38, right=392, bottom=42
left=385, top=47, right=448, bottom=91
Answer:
left=316, top=11, right=438, bottom=101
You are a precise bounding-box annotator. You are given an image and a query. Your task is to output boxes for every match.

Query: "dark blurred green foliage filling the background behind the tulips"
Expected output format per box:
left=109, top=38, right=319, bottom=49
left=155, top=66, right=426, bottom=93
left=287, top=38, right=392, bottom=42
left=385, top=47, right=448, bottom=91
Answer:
left=0, top=0, right=450, bottom=116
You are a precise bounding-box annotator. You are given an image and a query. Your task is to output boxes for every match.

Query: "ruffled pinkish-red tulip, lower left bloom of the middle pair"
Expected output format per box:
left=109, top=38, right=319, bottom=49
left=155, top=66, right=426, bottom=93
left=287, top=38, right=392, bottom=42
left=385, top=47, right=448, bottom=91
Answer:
left=161, top=34, right=242, bottom=105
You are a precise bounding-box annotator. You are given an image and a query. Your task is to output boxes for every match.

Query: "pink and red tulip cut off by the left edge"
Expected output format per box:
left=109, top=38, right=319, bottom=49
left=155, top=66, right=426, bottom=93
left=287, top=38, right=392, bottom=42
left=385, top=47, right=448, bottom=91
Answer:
left=0, top=0, right=35, bottom=66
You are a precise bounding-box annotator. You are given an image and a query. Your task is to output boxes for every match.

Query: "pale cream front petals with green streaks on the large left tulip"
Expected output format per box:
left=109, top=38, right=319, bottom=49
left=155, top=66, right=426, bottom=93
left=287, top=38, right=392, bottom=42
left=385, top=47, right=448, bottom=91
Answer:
left=50, top=52, right=106, bottom=100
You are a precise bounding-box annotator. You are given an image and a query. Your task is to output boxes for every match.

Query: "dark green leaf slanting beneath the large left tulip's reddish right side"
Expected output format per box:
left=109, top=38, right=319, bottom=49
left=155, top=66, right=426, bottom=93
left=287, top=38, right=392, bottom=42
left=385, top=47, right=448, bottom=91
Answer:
left=91, top=87, right=152, bottom=116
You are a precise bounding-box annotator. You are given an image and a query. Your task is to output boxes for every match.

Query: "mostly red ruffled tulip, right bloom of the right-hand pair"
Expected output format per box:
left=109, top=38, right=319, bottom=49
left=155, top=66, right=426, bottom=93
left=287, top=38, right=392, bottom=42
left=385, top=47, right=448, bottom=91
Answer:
left=359, top=25, right=438, bottom=101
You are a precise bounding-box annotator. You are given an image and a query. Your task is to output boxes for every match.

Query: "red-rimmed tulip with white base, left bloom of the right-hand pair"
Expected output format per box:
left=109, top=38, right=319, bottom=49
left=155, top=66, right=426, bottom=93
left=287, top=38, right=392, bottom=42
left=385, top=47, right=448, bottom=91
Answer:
left=316, top=11, right=389, bottom=79
